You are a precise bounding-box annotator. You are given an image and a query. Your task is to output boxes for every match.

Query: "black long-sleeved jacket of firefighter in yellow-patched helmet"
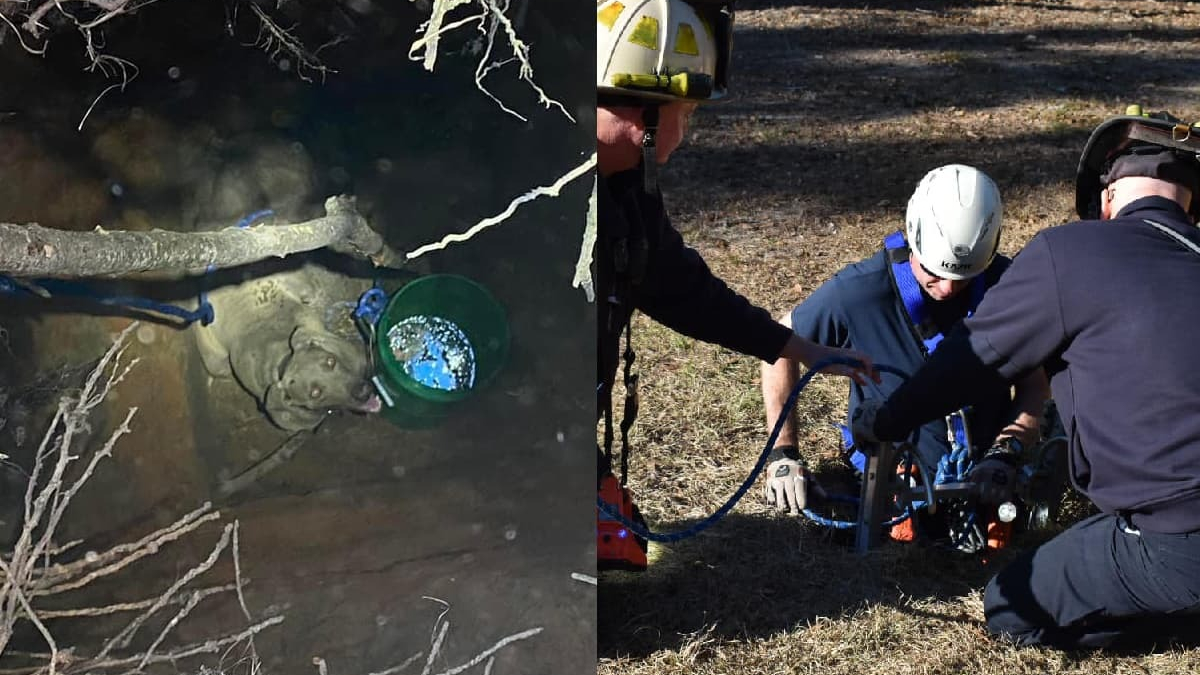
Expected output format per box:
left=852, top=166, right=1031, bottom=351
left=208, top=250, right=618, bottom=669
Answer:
left=594, top=169, right=791, bottom=405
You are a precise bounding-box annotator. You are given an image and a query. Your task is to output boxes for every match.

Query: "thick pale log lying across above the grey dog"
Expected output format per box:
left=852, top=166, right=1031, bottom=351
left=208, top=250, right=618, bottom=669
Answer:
left=0, top=196, right=404, bottom=279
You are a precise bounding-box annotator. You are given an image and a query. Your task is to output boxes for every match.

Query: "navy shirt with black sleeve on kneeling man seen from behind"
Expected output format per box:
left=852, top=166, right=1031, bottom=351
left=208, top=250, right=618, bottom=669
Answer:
left=876, top=197, right=1200, bottom=533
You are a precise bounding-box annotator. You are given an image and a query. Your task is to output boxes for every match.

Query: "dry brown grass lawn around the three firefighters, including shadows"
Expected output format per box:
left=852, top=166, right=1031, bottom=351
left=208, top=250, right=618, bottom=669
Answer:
left=599, top=0, right=1200, bottom=675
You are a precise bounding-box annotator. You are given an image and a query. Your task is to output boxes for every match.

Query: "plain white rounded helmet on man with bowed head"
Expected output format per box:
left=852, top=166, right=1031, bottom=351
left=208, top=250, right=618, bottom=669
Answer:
left=905, top=165, right=1002, bottom=279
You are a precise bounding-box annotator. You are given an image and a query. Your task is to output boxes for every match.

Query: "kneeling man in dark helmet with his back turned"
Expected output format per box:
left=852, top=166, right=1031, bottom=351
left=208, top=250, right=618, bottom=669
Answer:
left=852, top=109, right=1200, bottom=649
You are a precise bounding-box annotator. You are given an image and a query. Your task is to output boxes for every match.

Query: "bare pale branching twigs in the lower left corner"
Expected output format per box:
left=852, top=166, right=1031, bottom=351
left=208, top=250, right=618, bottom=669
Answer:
left=0, top=324, right=283, bottom=675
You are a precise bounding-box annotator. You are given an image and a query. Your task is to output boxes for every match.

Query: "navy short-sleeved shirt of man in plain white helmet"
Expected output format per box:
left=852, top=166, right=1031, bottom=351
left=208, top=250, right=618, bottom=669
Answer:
left=792, top=250, right=1013, bottom=466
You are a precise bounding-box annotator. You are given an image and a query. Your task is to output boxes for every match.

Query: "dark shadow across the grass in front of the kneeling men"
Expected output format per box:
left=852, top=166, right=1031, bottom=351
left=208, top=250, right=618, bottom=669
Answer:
left=598, top=514, right=1015, bottom=658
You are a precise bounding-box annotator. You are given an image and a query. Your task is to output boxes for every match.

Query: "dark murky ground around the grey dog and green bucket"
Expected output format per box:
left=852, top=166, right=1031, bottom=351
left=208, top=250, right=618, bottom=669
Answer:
left=0, top=2, right=595, bottom=674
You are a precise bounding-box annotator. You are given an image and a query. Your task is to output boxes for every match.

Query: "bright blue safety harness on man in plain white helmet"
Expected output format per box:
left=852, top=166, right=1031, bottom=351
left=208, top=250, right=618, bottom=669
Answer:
left=838, top=232, right=988, bottom=484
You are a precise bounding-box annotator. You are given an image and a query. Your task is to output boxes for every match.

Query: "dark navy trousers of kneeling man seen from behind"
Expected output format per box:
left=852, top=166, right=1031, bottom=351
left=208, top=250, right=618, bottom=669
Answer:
left=984, top=514, right=1200, bottom=649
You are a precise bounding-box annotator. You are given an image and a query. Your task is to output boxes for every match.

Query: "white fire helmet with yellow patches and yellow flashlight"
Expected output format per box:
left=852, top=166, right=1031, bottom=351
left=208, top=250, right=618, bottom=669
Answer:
left=596, top=0, right=733, bottom=101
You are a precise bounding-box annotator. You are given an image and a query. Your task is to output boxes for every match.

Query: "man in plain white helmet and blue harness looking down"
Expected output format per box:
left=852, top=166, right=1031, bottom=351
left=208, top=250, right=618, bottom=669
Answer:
left=762, top=165, right=1049, bottom=551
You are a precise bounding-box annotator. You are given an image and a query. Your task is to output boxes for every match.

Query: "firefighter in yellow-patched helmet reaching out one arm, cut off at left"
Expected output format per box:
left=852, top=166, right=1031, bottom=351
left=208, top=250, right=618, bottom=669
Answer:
left=594, top=0, right=872, bottom=567
